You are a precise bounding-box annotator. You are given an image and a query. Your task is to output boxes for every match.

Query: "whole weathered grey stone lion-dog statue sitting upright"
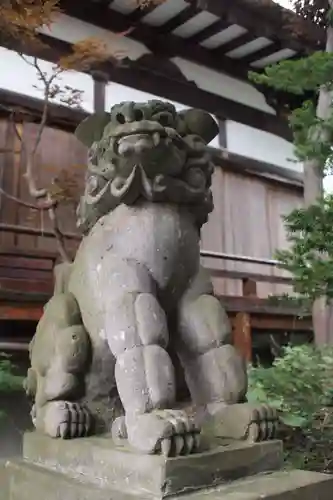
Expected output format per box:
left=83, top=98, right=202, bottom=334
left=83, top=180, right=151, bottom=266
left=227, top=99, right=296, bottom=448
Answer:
left=25, top=100, right=277, bottom=456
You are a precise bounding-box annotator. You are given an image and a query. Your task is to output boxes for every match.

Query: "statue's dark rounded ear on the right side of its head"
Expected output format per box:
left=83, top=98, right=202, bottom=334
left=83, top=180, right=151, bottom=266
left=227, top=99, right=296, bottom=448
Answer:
left=179, top=109, right=219, bottom=144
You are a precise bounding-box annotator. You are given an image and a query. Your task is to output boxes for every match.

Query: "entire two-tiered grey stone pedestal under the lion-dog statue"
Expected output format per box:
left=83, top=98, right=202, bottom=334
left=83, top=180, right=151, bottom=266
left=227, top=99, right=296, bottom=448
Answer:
left=0, top=433, right=333, bottom=500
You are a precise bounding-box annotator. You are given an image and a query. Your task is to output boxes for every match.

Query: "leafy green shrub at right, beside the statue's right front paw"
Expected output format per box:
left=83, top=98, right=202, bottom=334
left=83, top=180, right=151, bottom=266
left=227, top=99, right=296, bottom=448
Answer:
left=248, top=345, right=333, bottom=472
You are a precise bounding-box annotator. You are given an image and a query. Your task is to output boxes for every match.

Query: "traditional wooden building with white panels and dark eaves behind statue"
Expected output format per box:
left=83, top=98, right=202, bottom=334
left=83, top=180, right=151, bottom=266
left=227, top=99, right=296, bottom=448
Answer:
left=0, top=0, right=323, bottom=359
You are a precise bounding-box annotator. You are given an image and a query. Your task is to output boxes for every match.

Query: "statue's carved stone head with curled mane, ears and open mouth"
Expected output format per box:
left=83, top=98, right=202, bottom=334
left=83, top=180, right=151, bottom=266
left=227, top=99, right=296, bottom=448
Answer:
left=76, top=100, right=218, bottom=235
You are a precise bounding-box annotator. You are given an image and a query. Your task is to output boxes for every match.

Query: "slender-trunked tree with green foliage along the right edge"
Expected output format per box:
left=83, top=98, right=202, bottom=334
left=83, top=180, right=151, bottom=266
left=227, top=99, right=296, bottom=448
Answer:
left=250, top=0, right=333, bottom=344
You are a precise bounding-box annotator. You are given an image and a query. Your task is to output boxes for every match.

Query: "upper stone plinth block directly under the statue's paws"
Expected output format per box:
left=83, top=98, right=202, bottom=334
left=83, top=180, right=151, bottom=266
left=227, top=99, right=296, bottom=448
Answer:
left=23, top=433, right=283, bottom=497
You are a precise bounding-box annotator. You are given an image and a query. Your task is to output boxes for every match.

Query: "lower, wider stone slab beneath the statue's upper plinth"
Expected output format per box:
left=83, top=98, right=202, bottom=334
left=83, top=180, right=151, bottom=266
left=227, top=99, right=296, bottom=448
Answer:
left=0, top=462, right=333, bottom=500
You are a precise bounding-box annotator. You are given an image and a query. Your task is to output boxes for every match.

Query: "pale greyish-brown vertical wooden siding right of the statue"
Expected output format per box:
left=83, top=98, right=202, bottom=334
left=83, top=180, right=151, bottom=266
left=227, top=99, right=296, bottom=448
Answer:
left=201, top=168, right=302, bottom=298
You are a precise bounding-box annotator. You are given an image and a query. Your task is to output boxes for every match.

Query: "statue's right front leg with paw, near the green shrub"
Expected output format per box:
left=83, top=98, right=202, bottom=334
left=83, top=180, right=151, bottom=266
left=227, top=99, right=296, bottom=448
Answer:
left=178, top=270, right=277, bottom=441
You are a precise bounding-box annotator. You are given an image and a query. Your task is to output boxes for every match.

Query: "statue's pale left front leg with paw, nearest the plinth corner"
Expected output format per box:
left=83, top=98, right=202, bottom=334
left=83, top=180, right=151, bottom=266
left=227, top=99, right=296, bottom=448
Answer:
left=105, top=261, right=196, bottom=455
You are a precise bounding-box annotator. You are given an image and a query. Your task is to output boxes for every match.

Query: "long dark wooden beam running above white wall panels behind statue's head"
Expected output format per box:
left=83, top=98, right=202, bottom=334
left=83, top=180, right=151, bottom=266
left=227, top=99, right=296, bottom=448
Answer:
left=0, top=31, right=291, bottom=140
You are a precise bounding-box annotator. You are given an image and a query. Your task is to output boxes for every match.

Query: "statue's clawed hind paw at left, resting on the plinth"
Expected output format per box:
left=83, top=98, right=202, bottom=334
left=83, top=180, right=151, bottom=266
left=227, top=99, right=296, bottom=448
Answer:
left=35, top=401, right=92, bottom=439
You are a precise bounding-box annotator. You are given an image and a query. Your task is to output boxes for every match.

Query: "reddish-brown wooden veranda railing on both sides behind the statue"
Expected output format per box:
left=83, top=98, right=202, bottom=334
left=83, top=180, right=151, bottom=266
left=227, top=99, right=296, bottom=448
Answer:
left=0, top=225, right=312, bottom=361
